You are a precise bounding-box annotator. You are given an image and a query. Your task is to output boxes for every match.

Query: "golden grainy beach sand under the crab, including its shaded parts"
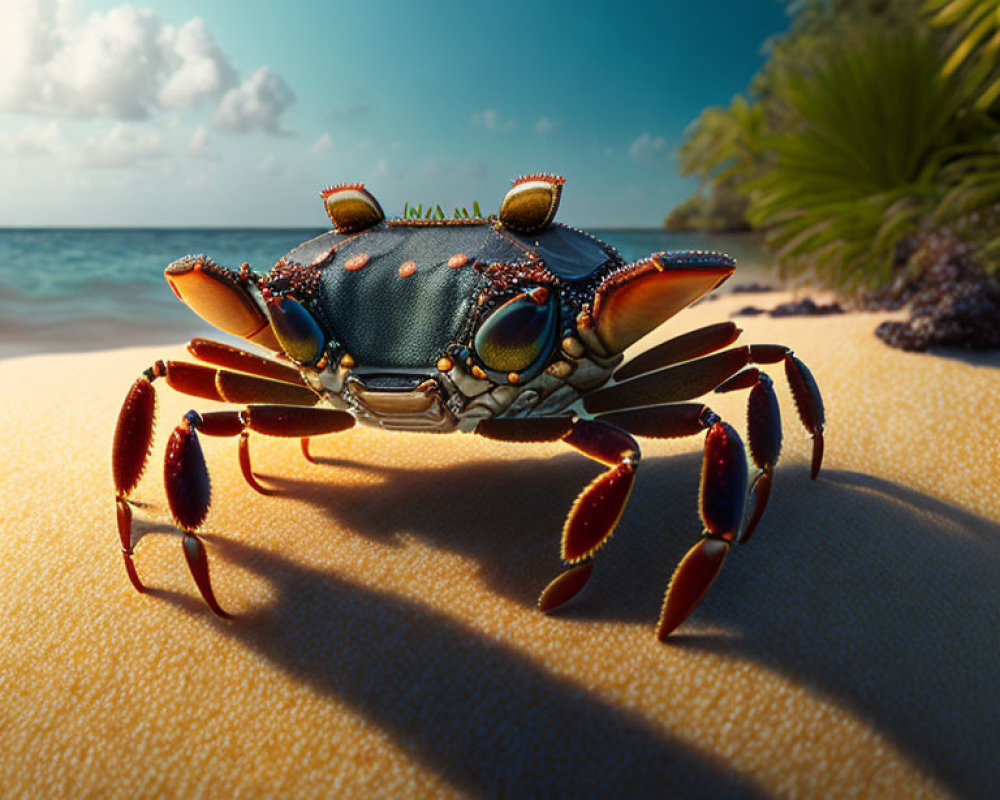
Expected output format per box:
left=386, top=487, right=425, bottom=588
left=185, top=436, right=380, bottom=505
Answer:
left=0, top=295, right=1000, bottom=798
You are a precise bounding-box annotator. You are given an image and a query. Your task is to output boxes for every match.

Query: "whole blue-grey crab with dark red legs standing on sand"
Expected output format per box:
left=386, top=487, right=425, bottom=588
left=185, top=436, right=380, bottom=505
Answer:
left=112, top=174, right=824, bottom=639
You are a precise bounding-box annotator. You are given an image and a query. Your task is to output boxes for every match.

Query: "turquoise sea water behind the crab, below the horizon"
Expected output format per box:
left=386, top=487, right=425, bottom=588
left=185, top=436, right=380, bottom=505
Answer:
left=0, top=228, right=768, bottom=356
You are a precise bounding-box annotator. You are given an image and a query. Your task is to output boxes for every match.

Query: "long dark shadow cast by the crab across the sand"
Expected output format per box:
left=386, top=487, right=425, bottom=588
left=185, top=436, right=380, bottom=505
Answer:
left=162, top=454, right=1000, bottom=797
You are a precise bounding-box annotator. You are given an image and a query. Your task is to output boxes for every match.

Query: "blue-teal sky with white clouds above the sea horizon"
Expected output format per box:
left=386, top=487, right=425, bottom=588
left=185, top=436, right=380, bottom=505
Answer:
left=0, top=0, right=788, bottom=227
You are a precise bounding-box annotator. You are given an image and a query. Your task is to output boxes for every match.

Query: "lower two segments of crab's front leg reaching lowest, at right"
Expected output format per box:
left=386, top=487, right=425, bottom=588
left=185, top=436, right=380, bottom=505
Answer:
left=656, top=422, right=747, bottom=640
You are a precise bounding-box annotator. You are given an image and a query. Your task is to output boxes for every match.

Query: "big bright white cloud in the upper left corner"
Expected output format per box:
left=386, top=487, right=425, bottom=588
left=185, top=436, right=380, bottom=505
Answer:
left=0, top=0, right=235, bottom=120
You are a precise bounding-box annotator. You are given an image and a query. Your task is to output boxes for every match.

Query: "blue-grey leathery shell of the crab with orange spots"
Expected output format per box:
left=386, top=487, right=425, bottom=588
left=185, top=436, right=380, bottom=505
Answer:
left=269, top=220, right=621, bottom=368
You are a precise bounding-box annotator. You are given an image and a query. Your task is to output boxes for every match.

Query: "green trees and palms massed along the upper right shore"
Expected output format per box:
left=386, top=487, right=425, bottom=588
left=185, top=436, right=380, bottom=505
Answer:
left=664, top=0, right=1000, bottom=289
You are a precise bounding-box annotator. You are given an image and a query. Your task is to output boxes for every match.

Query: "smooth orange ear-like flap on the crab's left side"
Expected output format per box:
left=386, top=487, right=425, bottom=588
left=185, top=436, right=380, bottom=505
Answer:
left=163, top=256, right=281, bottom=350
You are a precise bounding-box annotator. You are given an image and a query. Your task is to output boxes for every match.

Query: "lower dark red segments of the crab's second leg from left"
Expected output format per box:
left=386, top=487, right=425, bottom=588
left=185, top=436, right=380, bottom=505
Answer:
left=163, top=412, right=229, bottom=618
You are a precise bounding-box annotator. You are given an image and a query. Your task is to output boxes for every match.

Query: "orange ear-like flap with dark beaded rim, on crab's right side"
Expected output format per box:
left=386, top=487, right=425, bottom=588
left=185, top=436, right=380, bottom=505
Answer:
left=579, top=251, right=736, bottom=353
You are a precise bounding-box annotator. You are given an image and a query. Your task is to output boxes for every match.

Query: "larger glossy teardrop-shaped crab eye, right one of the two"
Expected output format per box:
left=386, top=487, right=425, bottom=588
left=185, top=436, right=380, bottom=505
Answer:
left=475, top=287, right=558, bottom=373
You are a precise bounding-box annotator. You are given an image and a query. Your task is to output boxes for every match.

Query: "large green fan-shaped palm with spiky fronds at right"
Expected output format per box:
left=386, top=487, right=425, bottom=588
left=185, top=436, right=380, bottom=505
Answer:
left=748, top=28, right=974, bottom=287
